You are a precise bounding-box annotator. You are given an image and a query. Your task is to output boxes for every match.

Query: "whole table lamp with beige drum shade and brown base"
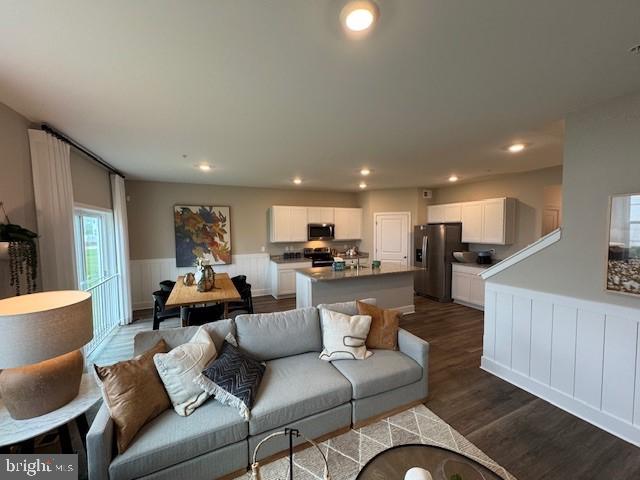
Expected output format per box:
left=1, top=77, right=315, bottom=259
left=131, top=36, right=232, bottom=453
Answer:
left=0, top=290, right=93, bottom=420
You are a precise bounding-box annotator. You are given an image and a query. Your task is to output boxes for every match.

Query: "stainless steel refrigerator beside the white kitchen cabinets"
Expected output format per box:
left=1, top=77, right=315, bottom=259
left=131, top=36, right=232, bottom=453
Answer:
left=413, top=223, right=467, bottom=302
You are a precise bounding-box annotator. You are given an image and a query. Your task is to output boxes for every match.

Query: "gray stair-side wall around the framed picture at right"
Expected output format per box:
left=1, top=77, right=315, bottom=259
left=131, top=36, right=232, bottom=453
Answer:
left=492, top=93, right=640, bottom=308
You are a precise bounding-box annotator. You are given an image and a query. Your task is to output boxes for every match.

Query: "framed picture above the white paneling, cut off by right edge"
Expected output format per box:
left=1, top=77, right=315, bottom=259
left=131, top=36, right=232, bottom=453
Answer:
left=607, top=194, right=640, bottom=295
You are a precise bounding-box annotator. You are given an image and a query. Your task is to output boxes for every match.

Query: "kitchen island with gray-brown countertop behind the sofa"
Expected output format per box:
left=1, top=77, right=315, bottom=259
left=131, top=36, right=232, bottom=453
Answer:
left=296, top=264, right=418, bottom=313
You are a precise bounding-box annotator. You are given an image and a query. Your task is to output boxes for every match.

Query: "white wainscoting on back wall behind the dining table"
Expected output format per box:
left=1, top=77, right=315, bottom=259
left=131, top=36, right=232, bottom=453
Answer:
left=131, top=253, right=271, bottom=310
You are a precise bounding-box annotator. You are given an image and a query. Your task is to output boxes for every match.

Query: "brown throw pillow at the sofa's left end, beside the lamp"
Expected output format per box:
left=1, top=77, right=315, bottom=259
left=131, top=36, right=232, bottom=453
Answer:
left=94, top=340, right=171, bottom=453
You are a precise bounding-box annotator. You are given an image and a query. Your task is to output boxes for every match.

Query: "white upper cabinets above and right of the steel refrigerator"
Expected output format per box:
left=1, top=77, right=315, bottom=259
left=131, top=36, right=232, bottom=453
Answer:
left=427, top=198, right=516, bottom=245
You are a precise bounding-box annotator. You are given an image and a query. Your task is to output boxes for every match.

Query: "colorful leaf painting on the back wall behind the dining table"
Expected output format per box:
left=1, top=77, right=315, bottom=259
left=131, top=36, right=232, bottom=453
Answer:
left=173, top=205, right=231, bottom=267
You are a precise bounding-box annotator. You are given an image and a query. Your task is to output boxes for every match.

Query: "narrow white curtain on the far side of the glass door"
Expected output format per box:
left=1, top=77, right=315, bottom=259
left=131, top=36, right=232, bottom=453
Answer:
left=111, top=174, right=133, bottom=325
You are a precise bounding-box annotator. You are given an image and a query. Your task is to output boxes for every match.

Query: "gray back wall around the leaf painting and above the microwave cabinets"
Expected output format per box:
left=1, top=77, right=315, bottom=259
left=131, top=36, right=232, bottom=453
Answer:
left=126, top=180, right=358, bottom=260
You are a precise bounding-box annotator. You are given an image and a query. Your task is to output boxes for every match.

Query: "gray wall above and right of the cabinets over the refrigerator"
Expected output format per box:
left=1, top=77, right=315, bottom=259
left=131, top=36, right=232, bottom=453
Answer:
left=434, top=167, right=562, bottom=259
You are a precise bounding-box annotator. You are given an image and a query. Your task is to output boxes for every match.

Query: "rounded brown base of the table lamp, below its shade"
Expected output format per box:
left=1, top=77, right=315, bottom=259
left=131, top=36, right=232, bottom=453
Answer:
left=0, top=350, right=84, bottom=420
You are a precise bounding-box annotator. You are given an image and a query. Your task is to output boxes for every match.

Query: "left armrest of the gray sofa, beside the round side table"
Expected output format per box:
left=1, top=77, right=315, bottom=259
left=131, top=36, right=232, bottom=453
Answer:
left=87, top=402, right=114, bottom=480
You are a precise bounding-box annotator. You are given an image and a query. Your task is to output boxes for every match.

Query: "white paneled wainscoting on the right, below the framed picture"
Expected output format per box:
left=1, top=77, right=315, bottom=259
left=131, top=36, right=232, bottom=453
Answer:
left=482, top=281, right=640, bottom=446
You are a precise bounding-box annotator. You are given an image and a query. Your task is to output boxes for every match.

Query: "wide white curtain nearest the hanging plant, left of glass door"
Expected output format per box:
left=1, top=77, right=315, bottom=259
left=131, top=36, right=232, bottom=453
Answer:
left=29, top=130, right=77, bottom=290
